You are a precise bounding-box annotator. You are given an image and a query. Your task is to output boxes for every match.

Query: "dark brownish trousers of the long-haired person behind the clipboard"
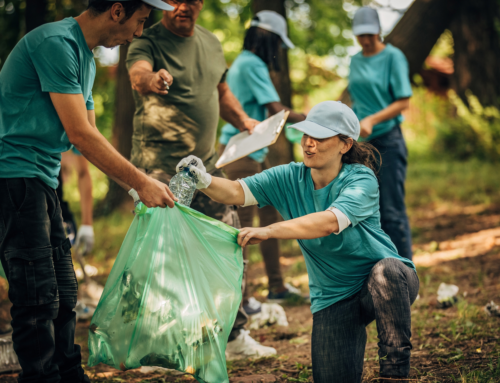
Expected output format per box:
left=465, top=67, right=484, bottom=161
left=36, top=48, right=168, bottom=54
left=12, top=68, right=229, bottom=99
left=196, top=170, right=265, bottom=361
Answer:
left=221, top=154, right=284, bottom=295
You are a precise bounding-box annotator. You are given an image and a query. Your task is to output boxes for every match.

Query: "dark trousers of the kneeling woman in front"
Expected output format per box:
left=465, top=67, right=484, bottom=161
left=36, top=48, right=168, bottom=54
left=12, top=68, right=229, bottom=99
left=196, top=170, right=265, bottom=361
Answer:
left=311, top=258, right=419, bottom=383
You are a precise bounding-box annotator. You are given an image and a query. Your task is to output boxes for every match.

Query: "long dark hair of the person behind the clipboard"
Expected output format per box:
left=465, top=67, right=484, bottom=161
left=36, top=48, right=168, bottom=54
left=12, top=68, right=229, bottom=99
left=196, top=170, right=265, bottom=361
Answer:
left=243, top=16, right=282, bottom=72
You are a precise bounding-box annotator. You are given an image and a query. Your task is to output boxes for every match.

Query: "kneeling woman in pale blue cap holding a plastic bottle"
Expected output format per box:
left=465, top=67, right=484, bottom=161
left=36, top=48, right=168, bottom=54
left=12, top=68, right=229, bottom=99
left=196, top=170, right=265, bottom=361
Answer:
left=177, top=101, right=419, bottom=383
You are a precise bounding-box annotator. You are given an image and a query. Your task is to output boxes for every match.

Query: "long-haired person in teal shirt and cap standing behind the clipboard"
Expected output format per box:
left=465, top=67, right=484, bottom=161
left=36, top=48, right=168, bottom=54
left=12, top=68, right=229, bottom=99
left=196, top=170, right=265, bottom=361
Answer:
left=219, top=11, right=305, bottom=315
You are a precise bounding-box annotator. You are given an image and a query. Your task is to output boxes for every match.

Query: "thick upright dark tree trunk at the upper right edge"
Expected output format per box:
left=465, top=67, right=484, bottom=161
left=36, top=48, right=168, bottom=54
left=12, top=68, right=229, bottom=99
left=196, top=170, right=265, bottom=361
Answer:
left=450, top=0, right=500, bottom=108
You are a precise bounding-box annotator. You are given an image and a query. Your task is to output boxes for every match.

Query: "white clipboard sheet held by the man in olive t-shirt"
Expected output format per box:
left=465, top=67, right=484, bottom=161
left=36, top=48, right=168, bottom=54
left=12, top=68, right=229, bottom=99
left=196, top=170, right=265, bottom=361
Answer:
left=215, top=110, right=290, bottom=169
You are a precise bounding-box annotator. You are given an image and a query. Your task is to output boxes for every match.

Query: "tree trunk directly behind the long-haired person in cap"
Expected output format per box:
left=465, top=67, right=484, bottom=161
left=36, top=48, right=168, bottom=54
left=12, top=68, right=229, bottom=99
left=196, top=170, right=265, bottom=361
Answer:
left=253, top=0, right=293, bottom=166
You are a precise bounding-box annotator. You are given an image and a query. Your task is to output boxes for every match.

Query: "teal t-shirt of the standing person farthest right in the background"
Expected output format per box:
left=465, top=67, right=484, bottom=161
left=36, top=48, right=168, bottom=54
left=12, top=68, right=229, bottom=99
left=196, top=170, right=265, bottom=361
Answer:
left=348, top=44, right=412, bottom=140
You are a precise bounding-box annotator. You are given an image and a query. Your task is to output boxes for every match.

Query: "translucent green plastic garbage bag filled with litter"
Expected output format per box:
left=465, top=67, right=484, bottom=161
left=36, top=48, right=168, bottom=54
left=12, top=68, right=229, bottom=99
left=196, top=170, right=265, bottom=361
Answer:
left=88, top=203, right=243, bottom=383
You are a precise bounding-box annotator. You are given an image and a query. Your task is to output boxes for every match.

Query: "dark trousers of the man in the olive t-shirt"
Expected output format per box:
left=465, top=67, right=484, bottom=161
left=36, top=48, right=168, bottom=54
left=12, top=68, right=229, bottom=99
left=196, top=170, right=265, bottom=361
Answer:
left=139, top=168, right=248, bottom=341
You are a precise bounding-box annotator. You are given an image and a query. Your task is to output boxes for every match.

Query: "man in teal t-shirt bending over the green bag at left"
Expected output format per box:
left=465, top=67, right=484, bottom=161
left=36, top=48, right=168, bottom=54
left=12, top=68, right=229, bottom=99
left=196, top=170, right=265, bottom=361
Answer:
left=0, top=0, right=178, bottom=383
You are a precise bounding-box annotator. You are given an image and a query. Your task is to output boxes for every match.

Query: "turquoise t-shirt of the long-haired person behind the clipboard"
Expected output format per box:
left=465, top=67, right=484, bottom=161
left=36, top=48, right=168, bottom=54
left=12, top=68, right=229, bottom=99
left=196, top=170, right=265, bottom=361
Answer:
left=219, top=50, right=280, bottom=162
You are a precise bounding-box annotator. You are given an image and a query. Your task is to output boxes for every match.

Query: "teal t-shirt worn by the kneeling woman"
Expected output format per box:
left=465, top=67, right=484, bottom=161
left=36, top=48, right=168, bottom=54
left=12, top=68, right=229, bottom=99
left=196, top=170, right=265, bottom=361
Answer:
left=243, top=162, right=415, bottom=313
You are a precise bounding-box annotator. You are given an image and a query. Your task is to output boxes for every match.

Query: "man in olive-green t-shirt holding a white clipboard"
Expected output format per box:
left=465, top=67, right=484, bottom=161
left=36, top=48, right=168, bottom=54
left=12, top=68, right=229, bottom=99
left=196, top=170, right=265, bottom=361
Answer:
left=127, top=0, right=276, bottom=360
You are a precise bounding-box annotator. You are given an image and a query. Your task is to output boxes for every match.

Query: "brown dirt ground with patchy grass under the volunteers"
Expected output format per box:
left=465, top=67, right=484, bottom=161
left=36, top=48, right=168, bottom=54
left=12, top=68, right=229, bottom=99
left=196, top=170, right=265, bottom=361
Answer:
left=0, top=202, right=500, bottom=383
